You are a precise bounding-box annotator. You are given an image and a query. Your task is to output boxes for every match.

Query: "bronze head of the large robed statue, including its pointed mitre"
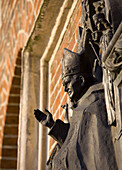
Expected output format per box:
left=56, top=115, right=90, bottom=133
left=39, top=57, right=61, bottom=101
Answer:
left=61, top=49, right=92, bottom=102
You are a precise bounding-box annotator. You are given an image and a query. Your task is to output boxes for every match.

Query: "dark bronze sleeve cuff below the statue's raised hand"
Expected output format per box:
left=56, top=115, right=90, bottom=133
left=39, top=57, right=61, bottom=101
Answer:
left=48, top=119, right=70, bottom=146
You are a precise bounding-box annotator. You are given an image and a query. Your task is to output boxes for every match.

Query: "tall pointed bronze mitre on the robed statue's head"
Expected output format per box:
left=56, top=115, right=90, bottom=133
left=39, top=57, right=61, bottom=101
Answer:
left=61, top=48, right=92, bottom=79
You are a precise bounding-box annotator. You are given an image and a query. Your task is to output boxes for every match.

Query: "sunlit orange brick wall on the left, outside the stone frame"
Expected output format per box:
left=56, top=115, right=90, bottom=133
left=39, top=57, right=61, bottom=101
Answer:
left=0, top=0, right=43, bottom=168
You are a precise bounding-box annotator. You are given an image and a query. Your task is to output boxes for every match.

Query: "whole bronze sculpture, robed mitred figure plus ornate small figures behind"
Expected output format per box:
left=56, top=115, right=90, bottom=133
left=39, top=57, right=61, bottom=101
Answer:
left=34, top=0, right=122, bottom=170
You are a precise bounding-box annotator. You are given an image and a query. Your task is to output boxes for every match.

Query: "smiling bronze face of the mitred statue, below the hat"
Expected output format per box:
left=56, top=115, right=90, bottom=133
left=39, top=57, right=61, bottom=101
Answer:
left=63, top=75, right=83, bottom=102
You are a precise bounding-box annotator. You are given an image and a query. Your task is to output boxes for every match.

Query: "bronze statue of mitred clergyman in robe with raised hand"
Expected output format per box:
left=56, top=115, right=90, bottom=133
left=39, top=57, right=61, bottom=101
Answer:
left=34, top=49, right=117, bottom=170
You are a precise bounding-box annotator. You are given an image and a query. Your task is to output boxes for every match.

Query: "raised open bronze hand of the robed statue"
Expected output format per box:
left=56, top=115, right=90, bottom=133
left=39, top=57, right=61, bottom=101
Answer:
left=34, top=109, right=54, bottom=128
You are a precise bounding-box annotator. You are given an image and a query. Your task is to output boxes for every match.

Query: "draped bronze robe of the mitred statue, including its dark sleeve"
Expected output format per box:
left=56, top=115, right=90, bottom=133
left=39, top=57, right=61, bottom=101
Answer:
left=49, top=84, right=118, bottom=170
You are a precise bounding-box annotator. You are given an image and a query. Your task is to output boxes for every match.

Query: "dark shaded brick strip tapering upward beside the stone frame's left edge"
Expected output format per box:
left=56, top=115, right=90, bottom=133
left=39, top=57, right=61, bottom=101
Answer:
left=0, top=50, right=21, bottom=169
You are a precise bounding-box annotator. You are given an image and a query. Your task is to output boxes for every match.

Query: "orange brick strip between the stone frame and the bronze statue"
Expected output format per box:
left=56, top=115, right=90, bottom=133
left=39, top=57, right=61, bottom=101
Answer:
left=49, top=0, right=81, bottom=155
